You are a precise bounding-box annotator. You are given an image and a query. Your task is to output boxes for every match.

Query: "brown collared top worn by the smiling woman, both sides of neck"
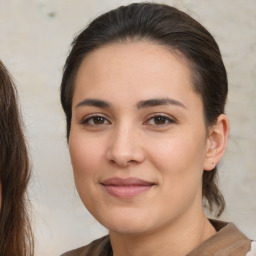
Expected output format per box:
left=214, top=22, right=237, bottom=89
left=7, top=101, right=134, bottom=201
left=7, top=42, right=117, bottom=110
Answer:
left=62, top=220, right=251, bottom=256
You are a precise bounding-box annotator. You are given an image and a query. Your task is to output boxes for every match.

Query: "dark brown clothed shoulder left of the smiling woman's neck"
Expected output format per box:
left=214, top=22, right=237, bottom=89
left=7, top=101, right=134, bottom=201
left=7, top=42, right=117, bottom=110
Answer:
left=61, top=236, right=112, bottom=256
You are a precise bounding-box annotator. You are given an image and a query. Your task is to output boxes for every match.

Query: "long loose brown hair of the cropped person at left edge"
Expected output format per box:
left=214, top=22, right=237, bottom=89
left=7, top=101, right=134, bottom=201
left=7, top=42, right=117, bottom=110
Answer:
left=0, top=61, right=34, bottom=256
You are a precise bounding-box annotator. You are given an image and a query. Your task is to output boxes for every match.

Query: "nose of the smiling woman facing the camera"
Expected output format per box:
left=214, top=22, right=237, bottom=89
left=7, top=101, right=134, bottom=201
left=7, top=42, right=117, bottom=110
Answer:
left=107, top=124, right=145, bottom=167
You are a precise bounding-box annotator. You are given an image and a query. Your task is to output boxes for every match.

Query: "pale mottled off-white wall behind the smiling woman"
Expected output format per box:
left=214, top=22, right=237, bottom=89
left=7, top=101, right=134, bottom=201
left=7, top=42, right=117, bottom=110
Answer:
left=0, top=0, right=256, bottom=256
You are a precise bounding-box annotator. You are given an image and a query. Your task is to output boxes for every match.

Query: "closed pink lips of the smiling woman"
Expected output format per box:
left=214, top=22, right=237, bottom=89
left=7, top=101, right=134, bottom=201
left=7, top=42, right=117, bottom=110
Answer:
left=101, top=177, right=155, bottom=198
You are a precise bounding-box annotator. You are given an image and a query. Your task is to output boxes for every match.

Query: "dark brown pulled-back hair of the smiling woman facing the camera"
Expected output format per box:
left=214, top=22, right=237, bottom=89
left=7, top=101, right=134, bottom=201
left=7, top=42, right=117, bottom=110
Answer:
left=61, top=3, right=228, bottom=216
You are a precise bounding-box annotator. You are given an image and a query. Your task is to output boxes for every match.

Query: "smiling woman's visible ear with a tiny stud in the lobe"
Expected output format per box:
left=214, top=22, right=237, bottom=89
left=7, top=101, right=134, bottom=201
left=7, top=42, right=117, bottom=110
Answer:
left=204, top=114, right=229, bottom=171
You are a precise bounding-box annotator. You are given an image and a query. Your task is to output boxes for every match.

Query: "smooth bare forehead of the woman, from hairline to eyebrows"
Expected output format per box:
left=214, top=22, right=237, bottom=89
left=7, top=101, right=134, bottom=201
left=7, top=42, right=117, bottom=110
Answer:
left=74, top=41, right=200, bottom=108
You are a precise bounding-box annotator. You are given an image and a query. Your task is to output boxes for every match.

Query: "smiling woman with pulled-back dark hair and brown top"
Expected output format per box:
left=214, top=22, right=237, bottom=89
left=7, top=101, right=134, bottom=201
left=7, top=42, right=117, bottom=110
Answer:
left=61, top=3, right=254, bottom=256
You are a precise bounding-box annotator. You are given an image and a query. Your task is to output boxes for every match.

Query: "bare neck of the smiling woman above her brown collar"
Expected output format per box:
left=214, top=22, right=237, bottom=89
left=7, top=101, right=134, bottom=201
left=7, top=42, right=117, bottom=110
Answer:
left=110, top=210, right=216, bottom=256
